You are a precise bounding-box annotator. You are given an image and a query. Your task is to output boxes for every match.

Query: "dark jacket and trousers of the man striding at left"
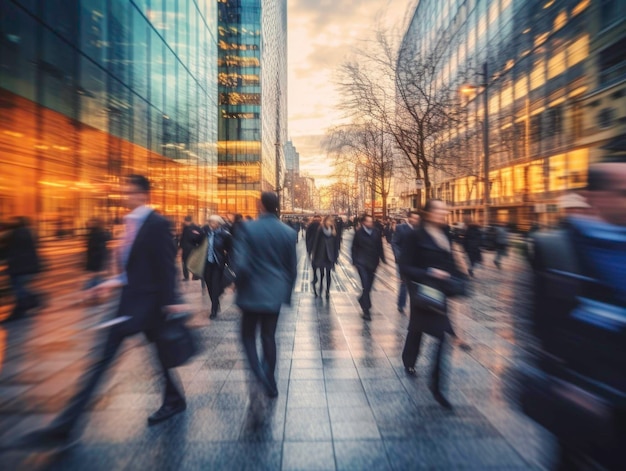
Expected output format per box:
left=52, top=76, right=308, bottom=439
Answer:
left=52, top=212, right=184, bottom=432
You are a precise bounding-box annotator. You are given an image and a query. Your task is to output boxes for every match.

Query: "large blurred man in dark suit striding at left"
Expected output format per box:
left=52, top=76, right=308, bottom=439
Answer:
left=16, top=175, right=186, bottom=449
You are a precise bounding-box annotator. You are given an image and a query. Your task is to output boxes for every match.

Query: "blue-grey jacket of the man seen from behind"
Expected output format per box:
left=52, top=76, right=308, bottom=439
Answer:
left=233, top=214, right=297, bottom=313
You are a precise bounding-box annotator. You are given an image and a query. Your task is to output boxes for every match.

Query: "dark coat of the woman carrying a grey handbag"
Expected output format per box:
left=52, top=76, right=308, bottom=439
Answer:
left=399, top=227, right=465, bottom=336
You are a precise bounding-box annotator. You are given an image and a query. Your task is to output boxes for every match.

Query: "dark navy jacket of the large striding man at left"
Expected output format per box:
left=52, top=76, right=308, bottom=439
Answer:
left=117, top=211, right=176, bottom=337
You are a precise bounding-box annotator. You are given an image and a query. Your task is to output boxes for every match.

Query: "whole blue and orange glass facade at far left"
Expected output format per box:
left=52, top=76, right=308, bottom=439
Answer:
left=0, top=0, right=218, bottom=235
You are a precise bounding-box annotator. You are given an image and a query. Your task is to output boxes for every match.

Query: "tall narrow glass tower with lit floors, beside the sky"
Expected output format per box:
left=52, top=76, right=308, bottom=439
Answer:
left=218, top=0, right=287, bottom=215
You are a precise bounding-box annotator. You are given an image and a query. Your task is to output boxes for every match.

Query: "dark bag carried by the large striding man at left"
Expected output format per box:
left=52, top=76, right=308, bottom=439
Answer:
left=155, top=314, right=198, bottom=368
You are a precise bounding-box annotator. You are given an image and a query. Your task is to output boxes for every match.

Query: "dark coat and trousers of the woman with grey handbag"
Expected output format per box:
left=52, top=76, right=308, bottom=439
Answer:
left=399, top=226, right=464, bottom=389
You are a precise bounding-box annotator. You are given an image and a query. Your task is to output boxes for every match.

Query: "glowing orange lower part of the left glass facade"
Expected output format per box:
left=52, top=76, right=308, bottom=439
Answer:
left=0, top=90, right=216, bottom=236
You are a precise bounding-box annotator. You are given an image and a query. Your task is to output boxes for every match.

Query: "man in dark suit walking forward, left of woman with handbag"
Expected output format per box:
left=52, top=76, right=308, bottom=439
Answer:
left=352, top=214, right=387, bottom=321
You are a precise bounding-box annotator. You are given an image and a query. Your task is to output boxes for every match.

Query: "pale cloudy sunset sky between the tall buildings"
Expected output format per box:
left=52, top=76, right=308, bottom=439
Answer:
left=288, top=0, right=417, bottom=188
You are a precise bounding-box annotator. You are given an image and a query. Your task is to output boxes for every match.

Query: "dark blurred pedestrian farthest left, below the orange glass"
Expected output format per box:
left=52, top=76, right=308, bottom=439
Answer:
left=5, top=216, right=41, bottom=322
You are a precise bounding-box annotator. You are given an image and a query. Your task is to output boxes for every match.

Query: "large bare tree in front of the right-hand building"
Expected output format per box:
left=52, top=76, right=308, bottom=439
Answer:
left=338, top=31, right=472, bottom=206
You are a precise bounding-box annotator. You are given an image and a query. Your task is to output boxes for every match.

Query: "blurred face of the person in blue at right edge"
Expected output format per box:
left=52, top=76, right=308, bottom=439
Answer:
left=588, top=162, right=626, bottom=226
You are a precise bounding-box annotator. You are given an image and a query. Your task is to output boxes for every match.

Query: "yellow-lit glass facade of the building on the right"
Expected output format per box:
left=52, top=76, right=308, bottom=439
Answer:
left=404, top=0, right=626, bottom=227
